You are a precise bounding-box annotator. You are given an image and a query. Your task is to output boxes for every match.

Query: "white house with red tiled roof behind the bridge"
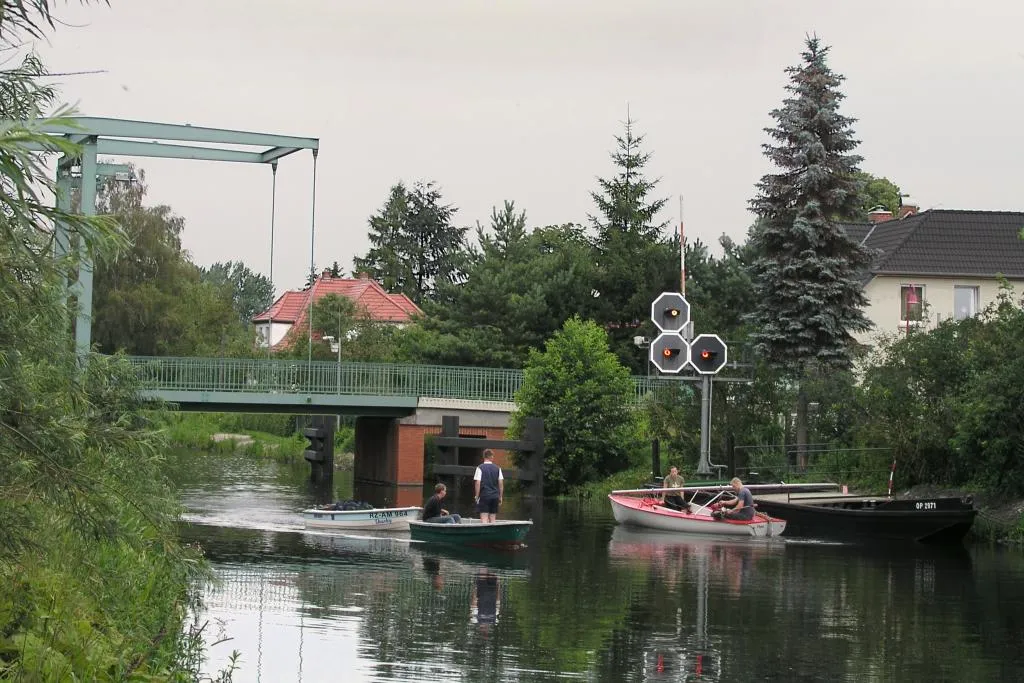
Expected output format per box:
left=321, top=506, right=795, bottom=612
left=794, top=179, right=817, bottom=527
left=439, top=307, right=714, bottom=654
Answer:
left=252, top=270, right=423, bottom=349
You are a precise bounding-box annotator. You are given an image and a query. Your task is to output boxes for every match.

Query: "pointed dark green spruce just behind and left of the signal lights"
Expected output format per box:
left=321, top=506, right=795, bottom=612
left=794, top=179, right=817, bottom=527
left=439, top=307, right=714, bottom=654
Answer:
left=590, top=117, right=679, bottom=372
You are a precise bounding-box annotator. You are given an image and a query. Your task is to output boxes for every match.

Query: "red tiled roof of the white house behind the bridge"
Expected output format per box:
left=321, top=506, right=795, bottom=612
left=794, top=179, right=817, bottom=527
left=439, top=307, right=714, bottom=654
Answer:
left=253, top=273, right=423, bottom=346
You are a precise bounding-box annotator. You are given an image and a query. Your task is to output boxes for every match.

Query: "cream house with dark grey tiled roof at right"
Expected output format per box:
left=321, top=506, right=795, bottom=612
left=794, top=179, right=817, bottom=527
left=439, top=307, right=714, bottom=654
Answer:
left=844, top=207, right=1024, bottom=344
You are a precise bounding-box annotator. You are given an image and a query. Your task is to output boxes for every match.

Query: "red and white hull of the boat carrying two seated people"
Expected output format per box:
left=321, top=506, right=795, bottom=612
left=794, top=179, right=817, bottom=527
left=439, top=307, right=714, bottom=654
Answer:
left=608, top=494, right=786, bottom=537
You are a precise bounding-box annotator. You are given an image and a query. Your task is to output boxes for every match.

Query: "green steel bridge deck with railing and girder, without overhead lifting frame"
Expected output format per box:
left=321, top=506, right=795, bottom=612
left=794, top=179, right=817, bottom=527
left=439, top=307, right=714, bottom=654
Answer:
left=128, top=356, right=689, bottom=417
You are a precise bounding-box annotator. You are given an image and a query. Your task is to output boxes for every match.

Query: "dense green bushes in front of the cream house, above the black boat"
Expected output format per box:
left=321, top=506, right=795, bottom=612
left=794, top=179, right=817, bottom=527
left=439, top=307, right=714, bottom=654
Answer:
left=863, top=286, right=1024, bottom=496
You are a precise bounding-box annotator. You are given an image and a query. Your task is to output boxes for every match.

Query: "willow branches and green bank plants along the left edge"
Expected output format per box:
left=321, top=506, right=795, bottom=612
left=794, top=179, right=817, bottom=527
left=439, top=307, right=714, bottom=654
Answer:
left=0, top=0, right=237, bottom=681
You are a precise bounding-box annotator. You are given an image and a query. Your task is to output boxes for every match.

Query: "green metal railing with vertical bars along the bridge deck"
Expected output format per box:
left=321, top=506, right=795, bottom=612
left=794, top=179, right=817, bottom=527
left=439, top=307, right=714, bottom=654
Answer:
left=128, top=356, right=692, bottom=402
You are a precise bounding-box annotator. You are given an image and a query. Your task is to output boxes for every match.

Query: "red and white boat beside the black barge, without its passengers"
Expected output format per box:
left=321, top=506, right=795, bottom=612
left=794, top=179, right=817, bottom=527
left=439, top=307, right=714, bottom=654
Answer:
left=608, top=486, right=785, bottom=538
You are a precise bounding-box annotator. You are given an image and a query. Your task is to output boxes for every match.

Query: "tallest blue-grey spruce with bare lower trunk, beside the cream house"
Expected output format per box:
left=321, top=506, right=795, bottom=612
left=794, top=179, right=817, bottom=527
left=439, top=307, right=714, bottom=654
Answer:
left=749, top=37, right=870, bottom=467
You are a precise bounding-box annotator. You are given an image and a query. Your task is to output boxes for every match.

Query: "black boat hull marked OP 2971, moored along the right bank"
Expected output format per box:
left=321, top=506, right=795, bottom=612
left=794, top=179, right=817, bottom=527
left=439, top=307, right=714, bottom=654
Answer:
left=756, top=498, right=977, bottom=544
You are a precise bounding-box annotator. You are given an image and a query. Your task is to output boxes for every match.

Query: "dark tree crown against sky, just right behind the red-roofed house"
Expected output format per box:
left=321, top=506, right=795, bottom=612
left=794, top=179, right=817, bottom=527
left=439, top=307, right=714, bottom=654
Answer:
left=354, top=182, right=467, bottom=304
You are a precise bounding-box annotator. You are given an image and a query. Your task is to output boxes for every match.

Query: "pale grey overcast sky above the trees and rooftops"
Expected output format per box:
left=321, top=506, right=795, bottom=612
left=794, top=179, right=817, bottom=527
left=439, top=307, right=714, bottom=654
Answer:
left=39, top=0, right=1024, bottom=292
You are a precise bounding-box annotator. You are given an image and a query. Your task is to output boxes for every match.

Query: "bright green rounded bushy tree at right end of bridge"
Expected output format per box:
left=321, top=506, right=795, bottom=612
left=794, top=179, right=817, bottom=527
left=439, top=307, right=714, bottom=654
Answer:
left=509, top=317, right=638, bottom=495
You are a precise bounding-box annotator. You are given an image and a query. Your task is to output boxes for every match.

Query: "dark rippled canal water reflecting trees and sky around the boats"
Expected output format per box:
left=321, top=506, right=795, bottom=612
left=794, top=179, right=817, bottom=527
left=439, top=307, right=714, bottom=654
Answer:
left=170, top=454, right=1024, bottom=683
